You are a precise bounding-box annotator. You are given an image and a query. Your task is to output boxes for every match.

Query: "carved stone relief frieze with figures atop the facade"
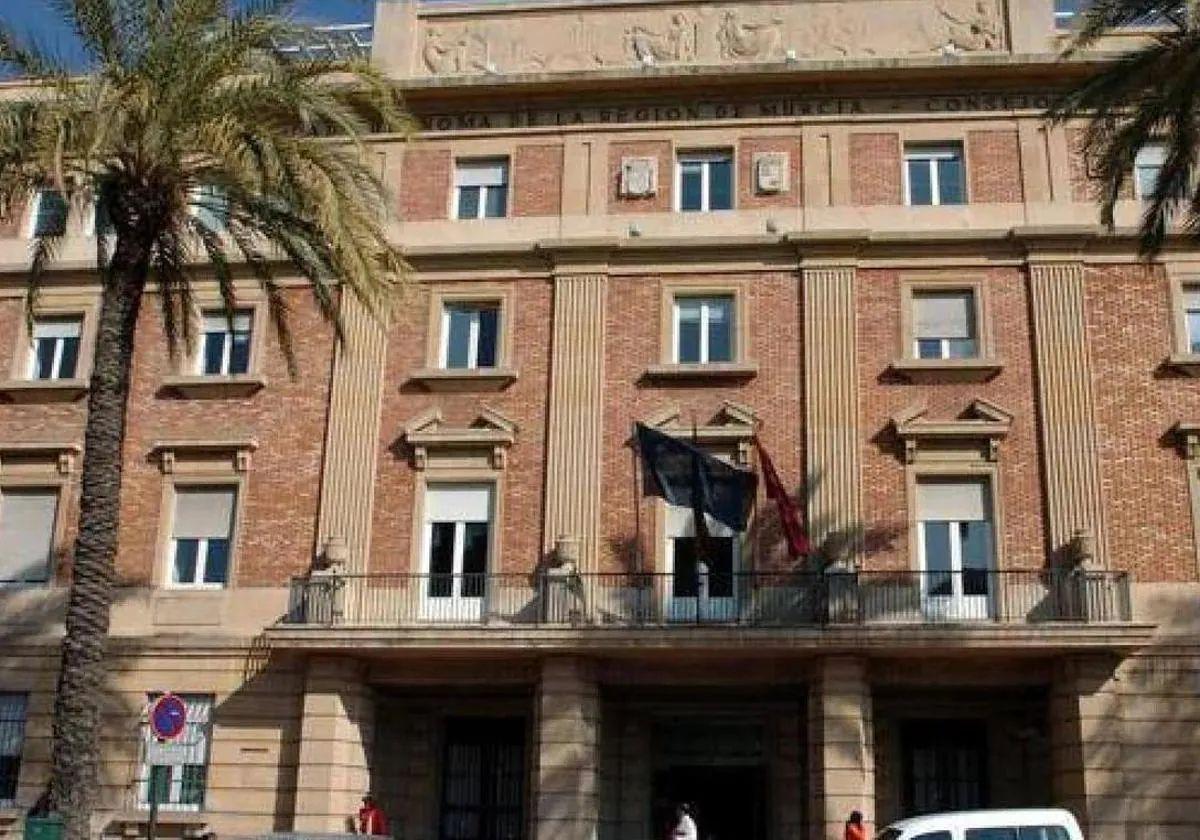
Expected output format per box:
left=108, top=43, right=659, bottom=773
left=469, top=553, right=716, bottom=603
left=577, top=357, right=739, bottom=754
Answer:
left=418, top=0, right=1007, bottom=76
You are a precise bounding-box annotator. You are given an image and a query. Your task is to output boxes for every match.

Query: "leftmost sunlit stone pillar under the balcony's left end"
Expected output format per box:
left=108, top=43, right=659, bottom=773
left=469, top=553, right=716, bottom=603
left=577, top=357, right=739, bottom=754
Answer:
left=294, top=656, right=374, bottom=833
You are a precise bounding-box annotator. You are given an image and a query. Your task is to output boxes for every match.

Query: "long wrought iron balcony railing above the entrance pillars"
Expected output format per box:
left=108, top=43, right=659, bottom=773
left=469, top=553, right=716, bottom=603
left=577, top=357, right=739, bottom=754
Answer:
left=284, top=570, right=1132, bottom=628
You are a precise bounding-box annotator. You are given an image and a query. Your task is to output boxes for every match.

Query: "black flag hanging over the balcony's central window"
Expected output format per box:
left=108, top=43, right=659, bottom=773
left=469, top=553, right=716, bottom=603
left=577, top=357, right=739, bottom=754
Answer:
left=637, top=424, right=757, bottom=536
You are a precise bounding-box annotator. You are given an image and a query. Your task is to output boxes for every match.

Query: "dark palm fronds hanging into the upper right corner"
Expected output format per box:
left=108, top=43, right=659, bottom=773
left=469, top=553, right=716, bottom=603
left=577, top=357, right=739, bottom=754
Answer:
left=1050, top=0, right=1200, bottom=256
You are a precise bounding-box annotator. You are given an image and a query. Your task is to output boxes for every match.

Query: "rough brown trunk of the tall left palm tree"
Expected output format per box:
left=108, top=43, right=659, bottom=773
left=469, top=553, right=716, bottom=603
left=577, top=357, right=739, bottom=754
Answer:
left=50, top=244, right=149, bottom=840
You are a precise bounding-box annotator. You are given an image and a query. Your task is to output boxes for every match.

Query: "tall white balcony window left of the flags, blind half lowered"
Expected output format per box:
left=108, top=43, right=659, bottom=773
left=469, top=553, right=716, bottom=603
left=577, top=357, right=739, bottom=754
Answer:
left=424, top=484, right=492, bottom=619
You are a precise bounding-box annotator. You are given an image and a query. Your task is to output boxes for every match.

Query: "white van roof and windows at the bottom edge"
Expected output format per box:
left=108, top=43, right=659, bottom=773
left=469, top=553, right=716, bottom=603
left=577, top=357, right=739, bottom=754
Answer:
left=876, top=808, right=1084, bottom=840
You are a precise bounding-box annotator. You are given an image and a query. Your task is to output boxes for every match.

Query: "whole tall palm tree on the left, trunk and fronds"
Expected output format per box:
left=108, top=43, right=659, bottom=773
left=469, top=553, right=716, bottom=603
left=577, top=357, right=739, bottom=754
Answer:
left=0, top=0, right=408, bottom=840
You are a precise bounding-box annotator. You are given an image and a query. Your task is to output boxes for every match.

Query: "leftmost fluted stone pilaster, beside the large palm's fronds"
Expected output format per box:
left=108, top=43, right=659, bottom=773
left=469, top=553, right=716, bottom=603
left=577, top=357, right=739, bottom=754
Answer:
left=317, top=294, right=388, bottom=572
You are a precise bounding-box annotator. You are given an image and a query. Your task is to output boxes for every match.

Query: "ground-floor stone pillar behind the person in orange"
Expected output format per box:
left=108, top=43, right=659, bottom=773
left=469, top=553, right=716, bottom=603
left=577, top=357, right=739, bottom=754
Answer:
left=809, top=656, right=875, bottom=840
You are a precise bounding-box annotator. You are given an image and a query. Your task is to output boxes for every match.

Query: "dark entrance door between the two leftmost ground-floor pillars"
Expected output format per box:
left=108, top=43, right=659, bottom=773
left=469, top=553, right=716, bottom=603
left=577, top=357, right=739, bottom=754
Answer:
left=438, top=718, right=526, bottom=840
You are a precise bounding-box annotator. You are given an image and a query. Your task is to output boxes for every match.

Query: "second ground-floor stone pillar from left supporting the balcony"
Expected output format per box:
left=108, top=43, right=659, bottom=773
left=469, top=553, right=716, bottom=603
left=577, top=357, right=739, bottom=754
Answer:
left=533, top=658, right=600, bottom=840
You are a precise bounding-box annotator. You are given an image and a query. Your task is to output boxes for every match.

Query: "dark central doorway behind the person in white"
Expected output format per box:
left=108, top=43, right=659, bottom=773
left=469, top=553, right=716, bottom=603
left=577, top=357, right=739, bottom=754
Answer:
left=654, top=766, right=767, bottom=840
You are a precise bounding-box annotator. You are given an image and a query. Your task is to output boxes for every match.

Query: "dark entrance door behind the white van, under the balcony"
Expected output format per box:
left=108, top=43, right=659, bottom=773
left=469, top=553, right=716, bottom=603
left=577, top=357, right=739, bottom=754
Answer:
left=902, top=720, right=989, bottom=816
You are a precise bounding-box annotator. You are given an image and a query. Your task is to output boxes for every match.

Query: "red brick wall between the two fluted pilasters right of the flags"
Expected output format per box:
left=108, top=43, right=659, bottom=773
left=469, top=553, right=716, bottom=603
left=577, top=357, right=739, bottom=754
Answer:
left=857, top=269, right=1045, bottom=569
